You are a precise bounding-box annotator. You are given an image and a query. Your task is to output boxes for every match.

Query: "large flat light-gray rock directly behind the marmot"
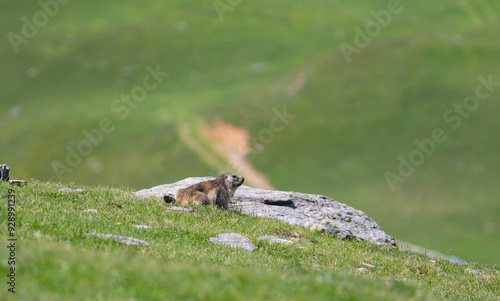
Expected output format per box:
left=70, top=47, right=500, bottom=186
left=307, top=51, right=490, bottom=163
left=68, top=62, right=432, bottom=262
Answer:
left=136, top=177, right=396, bottom=246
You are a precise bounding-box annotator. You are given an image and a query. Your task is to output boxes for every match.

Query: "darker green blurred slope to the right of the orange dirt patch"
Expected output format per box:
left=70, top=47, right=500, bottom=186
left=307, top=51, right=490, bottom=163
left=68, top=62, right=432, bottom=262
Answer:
left=217, top=29, right=500, bottom=262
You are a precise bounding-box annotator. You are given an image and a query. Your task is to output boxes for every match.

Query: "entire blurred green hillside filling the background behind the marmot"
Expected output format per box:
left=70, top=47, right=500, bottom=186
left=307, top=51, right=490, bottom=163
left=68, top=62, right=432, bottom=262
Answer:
left=0, top=0, right=500, bottom=264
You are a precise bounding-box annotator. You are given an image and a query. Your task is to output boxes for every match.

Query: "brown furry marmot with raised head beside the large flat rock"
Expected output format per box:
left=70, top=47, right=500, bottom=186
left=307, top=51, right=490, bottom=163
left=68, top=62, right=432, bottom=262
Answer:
left=163, top=173, right=245, bottom=210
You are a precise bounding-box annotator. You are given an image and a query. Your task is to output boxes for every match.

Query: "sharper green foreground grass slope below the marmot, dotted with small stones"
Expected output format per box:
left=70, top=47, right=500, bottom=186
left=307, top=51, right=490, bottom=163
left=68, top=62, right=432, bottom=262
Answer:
left=0, top=179, right=500, bottom=300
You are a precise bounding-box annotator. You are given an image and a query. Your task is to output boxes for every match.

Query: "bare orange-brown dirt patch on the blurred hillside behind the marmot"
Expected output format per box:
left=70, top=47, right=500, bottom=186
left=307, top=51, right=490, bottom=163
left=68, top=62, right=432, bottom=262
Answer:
left=201, top=121, right=274, bottom=189
